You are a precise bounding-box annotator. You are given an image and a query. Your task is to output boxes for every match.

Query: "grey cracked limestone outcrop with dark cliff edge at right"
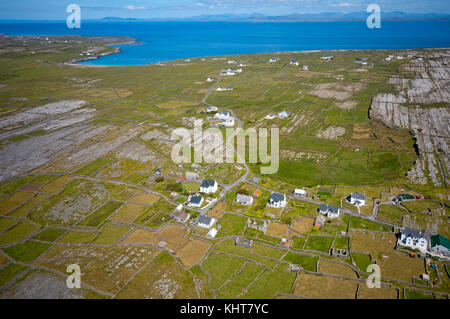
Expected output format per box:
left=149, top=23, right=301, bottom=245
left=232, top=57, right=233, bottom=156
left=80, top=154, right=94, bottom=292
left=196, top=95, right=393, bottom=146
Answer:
left=370, top=51, right=450, bottom=187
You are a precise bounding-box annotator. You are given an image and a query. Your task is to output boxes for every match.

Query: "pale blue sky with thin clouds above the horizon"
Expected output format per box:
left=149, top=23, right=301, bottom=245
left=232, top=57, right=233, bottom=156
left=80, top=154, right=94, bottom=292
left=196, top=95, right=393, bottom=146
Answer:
left=0, top=0, right=450, bottom=20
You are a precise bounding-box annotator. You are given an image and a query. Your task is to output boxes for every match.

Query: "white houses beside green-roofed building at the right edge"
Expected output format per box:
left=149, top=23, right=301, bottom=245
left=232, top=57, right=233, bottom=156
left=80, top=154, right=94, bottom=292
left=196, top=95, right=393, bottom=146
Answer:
left=397, top=227, right=450, bottom=259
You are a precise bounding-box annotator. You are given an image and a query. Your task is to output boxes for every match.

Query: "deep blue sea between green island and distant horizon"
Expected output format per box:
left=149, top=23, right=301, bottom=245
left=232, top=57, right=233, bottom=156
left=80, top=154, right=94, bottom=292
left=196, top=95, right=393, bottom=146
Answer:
left=0, top=20, right=450, bottom=66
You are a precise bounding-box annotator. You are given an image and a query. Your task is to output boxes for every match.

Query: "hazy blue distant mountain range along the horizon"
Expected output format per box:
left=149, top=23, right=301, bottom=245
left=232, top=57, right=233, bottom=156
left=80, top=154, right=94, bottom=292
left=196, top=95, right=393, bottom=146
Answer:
left=95, top=11, right=450, bottom=22
